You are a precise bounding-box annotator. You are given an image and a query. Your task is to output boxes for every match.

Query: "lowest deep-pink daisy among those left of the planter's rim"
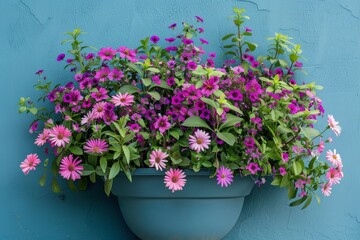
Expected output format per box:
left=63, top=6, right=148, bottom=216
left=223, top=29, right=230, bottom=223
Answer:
left=59, top=154, right=84, bottom=181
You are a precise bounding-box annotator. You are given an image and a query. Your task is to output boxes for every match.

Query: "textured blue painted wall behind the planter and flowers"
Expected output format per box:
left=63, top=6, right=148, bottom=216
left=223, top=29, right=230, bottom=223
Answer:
left=0, top=0, right=360, bottom=240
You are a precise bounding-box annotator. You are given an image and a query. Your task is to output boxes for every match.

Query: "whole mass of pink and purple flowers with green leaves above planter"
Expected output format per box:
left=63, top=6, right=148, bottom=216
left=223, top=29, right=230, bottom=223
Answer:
left=19, top=8, right=343, bottom=207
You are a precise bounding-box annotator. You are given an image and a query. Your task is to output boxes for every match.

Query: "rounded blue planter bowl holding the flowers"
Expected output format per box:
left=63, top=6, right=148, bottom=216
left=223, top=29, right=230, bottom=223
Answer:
left=112, top=168, right=254, bottom=240
